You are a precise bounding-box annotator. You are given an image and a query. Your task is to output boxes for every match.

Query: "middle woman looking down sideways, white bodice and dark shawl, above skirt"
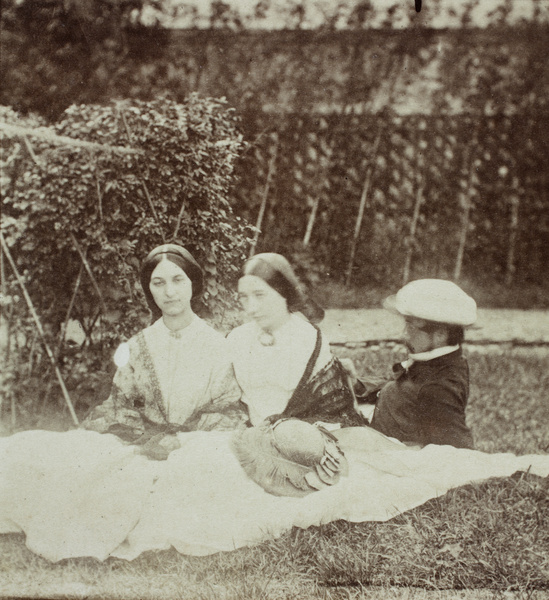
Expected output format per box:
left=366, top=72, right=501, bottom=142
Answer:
left=228, top=253, right=364, bottom=425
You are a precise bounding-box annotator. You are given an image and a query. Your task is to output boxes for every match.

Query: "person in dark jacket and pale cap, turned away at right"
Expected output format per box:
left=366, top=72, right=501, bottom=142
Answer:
left=360, top=279, right=477, bottom=448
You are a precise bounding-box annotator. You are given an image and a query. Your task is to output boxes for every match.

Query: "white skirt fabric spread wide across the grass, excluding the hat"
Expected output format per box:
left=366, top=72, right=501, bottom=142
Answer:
left=0, top=428, right=549, bottom=561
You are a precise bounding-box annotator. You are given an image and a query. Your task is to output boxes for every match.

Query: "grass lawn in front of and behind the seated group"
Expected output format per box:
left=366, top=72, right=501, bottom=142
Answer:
left=0, top=348, right=549, bottom=600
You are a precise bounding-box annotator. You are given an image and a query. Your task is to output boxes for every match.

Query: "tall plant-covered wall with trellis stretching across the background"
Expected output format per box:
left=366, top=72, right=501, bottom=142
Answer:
left=1, top=21, right=549, bottom=284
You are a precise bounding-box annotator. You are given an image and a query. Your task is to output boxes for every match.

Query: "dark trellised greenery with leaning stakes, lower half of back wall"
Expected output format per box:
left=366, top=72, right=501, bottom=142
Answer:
left=235, top=112, right=549, bottom=288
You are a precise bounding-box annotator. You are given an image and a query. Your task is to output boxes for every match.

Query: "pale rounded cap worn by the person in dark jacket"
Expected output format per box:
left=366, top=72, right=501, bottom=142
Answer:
left=383, top=279, right=477, bottom=327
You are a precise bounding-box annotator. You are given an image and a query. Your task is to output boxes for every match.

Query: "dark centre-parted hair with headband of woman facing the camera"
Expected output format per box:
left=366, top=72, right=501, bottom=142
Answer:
left=140, top=244, right=203, bottom=322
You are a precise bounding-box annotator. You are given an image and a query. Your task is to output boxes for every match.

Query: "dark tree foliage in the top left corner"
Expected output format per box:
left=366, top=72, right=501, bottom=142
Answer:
left=0, top=0, right=166, bottom=118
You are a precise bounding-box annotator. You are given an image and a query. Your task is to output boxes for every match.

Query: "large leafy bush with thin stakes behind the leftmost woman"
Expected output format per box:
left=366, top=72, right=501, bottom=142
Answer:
left=2, top=96, right=248, bottom=414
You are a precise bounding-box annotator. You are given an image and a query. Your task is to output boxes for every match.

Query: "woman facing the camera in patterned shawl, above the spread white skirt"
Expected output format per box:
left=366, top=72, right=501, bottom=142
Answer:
left=82, top=244, right=247, bottom=458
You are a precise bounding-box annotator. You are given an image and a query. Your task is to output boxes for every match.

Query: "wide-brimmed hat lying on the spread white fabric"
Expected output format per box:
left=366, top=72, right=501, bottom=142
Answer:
left=232, top=419, right=348, bottom=497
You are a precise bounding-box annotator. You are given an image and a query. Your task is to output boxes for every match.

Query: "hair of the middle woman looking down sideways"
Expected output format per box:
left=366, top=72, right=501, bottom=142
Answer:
left=243, top=252, right=324, bottom=323
